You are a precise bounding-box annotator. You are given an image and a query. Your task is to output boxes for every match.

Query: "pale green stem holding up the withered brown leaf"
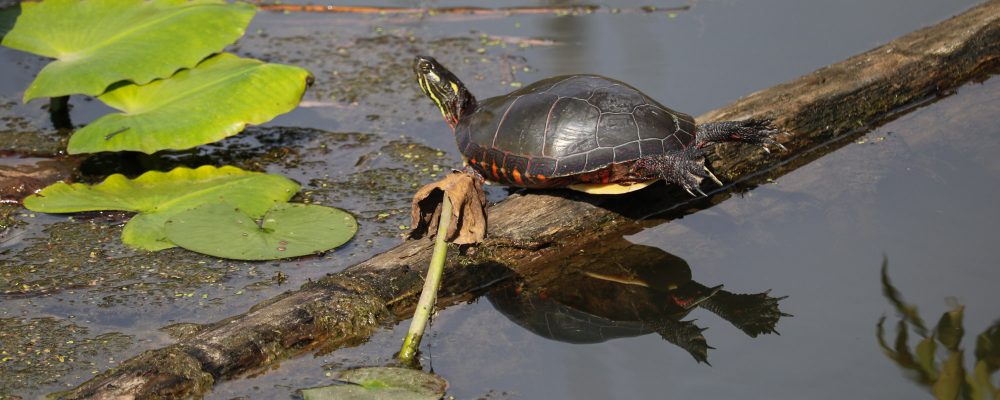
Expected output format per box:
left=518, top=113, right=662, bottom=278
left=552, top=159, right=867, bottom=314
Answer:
left=399, top=193, right=451, bottom=365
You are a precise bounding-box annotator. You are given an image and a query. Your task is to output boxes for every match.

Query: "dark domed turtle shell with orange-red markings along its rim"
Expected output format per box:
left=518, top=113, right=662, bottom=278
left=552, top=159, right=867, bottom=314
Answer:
left=455, top=75, right=695, bottom=187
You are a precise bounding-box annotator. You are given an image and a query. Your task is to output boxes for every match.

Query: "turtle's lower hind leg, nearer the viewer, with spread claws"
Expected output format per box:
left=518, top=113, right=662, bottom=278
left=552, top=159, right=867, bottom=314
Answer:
left=634, top=147, right=722, bottom=196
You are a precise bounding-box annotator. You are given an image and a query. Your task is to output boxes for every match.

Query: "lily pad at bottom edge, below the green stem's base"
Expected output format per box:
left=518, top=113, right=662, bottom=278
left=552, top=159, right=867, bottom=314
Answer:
left=302, top=367, right=448, bottom=400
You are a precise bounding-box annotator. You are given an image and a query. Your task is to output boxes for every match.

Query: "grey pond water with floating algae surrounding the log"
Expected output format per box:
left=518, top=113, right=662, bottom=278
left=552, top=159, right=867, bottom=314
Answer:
left=0, top=0, right=1000, bottom=399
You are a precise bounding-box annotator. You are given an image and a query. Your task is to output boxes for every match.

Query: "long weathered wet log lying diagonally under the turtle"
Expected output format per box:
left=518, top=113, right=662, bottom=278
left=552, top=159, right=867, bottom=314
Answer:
left=57, top=0, right=1000, bottom=399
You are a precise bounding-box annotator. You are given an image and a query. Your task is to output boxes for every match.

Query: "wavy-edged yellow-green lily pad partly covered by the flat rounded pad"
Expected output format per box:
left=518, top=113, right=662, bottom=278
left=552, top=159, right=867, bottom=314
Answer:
left=24, top=165, right=299, bottom=250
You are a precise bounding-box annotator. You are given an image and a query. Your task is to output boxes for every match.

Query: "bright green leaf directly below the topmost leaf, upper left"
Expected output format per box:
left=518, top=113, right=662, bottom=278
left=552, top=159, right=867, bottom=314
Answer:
left=68, top=53, right=311, bottom=154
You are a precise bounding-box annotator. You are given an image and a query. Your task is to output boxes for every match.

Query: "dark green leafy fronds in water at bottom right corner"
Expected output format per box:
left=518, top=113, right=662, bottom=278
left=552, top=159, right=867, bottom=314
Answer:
left=876, top=260, right=1000, bottom=400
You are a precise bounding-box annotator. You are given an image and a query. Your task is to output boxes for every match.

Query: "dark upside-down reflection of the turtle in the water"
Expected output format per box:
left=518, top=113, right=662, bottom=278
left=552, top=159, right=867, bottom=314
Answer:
left=487, top=239, right=789, bottom=363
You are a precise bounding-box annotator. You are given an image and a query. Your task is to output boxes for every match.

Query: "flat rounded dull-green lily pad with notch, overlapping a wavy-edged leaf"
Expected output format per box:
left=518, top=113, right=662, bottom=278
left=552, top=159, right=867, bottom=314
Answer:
left=166, top=203, right=358, bottom=260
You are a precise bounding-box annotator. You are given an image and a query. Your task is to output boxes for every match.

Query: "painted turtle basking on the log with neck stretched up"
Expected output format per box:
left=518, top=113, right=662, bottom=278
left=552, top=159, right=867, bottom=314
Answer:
left=413, top=55, right=784, bottom=196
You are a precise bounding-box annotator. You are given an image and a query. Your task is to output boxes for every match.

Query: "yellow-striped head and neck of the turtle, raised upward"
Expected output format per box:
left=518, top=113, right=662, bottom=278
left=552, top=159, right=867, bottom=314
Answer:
left=413, top=56, right=476, bottom=128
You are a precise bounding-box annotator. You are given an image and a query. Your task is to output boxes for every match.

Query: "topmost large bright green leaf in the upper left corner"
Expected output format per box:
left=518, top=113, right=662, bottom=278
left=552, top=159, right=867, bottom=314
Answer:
left=3, top=0, right=256, bottom=102
